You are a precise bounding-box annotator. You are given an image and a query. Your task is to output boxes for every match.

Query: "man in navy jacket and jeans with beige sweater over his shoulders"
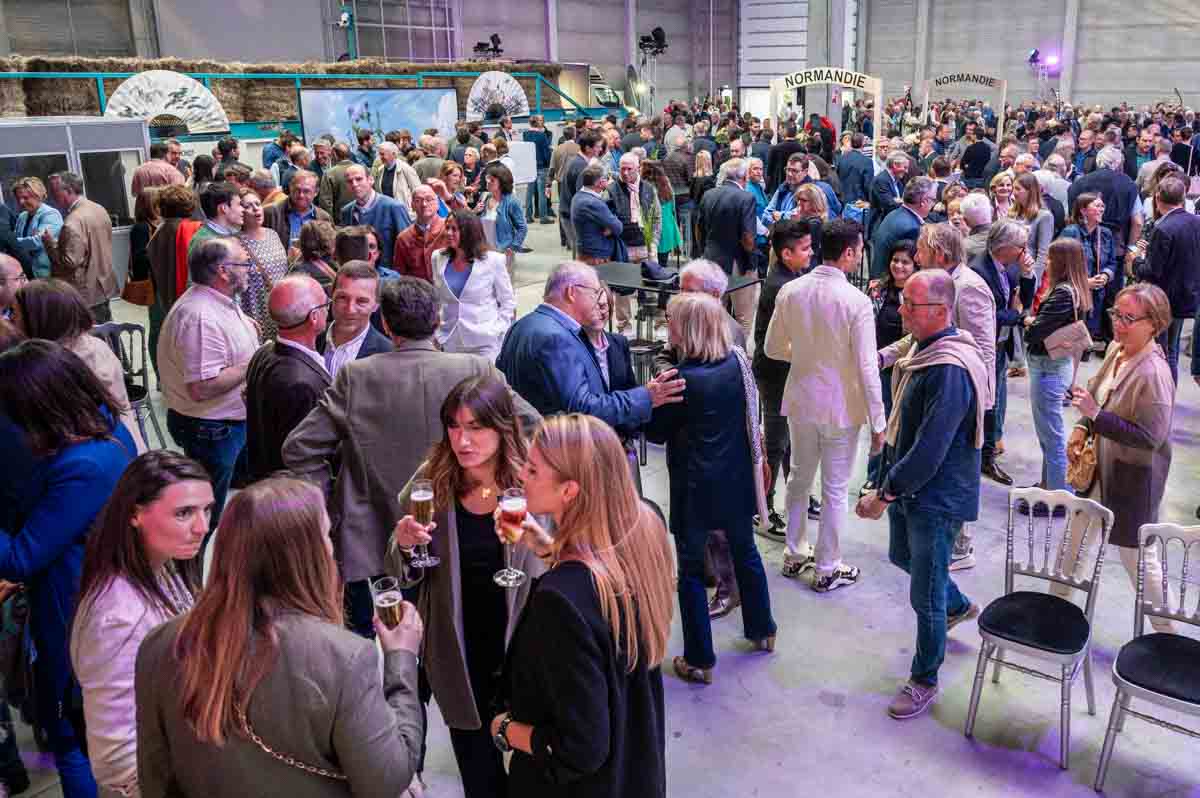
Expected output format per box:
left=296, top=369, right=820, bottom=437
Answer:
left=856, top=269, right=989, bottom=720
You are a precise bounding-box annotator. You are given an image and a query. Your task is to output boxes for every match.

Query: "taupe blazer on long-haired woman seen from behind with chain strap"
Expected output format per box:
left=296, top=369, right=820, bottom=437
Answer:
left=134, top=612, right=425, bottom=798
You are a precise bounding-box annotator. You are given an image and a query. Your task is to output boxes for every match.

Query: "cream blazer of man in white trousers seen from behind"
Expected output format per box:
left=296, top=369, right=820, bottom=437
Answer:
left=764, top=264, right=887, bottom=432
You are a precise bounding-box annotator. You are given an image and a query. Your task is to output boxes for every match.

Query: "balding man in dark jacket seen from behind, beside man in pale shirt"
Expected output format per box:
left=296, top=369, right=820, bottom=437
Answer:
left=246, top=275, right=331, bottom=481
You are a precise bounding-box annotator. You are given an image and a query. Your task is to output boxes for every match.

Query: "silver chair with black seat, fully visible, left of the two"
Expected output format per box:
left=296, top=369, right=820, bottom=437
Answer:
left=966, top=487, right=1112, bottom=769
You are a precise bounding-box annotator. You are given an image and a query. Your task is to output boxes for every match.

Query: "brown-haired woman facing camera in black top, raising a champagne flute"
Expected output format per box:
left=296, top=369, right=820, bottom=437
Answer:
left=388, top=376, right=545, bottom=798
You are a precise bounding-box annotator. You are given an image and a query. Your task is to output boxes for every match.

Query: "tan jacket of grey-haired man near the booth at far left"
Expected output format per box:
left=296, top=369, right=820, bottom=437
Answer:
left=48, top=197, right=116, bottom=307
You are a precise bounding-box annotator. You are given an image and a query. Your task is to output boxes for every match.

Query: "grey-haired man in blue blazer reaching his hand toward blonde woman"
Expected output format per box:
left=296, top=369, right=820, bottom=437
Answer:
left=496, top=260, right=684, bottom=430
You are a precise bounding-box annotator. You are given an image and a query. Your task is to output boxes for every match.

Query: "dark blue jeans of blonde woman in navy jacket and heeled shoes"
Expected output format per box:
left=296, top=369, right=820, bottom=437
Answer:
left=676, top=517, right=775, bottom=668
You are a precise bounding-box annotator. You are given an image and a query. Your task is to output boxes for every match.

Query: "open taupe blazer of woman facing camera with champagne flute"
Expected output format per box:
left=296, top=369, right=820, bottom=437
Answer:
left=386, top=463, right=547, bottom=730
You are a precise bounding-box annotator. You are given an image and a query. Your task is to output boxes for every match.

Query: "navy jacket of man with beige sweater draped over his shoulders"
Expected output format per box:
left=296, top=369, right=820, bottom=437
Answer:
left=882, top=328, right=980, bottom=521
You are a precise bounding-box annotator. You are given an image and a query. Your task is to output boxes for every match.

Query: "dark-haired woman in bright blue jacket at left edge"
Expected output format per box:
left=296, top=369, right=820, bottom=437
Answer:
left=0, top=341, right=136, bottom=798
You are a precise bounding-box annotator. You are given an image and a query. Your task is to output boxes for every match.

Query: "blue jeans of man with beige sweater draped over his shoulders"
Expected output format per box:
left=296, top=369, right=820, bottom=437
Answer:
left=888, top=500, right=971, bottom=685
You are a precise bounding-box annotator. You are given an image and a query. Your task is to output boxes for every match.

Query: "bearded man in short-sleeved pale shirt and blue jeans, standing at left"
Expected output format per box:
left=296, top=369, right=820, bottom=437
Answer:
left=158, top=238, right=259, bottom=544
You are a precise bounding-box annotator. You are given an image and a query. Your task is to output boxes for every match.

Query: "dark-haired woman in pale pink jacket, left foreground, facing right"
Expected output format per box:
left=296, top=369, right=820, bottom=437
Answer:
left=71, top=449, right=212, bottom=796
